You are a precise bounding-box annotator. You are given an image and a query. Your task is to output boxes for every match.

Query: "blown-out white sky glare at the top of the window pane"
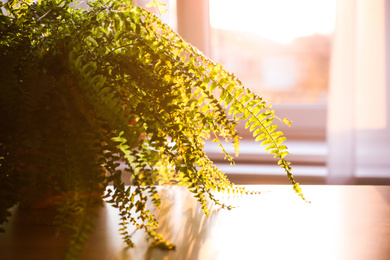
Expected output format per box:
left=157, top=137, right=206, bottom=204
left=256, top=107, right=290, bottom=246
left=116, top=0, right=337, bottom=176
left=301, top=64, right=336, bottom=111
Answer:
left=210, top=0, right=336, bottom=44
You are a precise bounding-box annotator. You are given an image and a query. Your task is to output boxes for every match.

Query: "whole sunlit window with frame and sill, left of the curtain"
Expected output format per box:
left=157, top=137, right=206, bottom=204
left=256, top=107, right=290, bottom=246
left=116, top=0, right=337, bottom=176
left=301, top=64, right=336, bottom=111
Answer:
left=163, top=0, right=335, bottom=183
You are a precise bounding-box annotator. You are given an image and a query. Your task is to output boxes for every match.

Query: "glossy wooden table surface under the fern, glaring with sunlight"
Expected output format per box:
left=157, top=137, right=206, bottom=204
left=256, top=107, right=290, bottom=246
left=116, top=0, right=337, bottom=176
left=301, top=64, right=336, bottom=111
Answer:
left=0, top=185, right=390, bottom=260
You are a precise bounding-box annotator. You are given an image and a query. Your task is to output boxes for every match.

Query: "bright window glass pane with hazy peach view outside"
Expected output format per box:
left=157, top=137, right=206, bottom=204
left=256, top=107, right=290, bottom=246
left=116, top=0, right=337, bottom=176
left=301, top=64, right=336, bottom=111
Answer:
left=210, top=0, right=335, bottom=104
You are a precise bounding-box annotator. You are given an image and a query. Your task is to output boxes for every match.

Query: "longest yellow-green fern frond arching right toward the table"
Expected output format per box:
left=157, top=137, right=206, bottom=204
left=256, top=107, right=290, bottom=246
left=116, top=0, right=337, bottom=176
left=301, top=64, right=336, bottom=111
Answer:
left=127, top=8, right=306, bottom=200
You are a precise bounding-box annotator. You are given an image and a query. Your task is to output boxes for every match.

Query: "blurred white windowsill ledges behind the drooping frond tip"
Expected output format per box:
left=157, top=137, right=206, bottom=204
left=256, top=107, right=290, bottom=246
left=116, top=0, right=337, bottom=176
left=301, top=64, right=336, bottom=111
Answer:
left=205, top=140, right=328, bottom=184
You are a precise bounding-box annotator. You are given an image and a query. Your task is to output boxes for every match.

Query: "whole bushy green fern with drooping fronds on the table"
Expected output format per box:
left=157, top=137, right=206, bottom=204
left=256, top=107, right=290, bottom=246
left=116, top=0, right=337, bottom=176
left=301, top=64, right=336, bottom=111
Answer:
left=0, top=0, right=305, bottom=258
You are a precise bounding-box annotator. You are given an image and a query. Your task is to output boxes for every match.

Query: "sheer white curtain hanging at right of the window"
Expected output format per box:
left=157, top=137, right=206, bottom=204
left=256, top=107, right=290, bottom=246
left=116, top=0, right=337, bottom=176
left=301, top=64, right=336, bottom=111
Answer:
left=327, top=0, right=390, bottom=184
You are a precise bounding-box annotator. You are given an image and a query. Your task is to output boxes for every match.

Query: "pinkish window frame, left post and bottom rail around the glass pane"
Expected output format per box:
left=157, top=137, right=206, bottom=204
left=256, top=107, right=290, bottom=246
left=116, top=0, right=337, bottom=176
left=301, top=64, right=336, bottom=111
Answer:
left=175, top=0, right=327, bottom=142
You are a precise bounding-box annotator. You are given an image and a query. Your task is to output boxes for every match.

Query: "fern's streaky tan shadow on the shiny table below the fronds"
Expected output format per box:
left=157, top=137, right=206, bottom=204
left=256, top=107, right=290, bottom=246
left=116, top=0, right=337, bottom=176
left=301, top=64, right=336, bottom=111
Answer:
left=139, top=187, right=221, bottom=260
